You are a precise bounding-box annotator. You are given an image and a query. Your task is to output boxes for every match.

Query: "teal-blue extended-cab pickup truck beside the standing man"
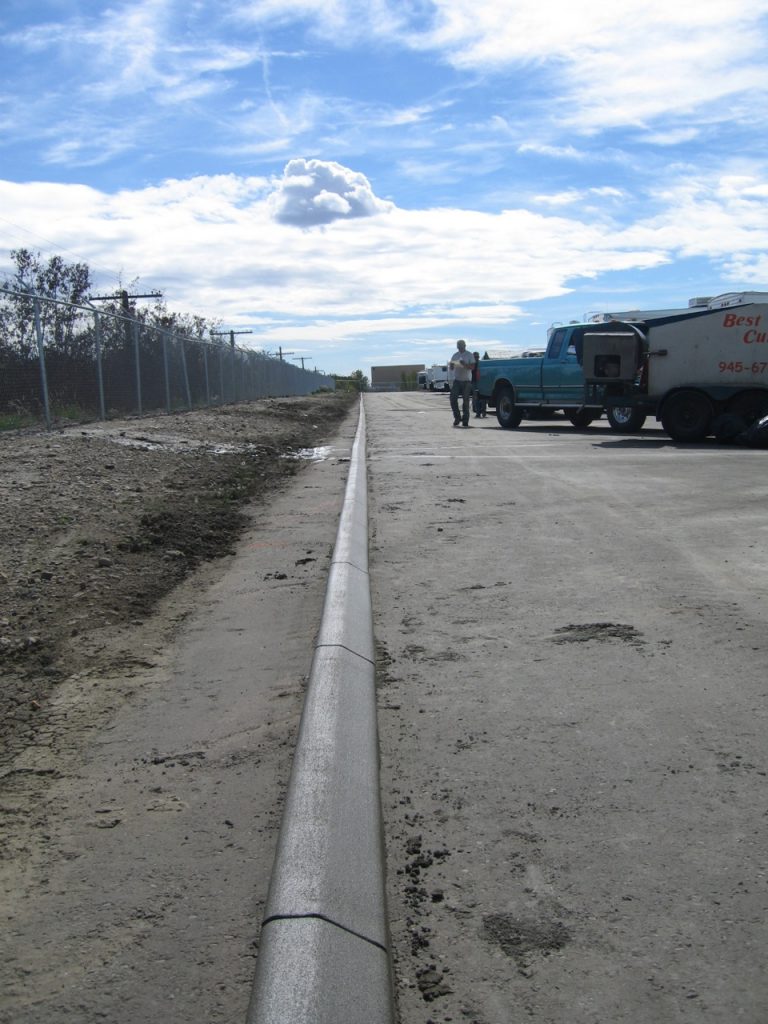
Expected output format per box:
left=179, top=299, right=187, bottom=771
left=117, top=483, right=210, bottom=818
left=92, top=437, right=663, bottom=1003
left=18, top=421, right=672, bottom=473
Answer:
left=478, top=324, right=645, bottom=433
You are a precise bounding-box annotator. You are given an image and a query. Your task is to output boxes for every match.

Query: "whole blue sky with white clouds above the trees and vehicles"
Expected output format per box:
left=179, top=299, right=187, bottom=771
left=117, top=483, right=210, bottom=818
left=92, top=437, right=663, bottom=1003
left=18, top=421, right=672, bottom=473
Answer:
left=0, top=0, right=768, bottom=376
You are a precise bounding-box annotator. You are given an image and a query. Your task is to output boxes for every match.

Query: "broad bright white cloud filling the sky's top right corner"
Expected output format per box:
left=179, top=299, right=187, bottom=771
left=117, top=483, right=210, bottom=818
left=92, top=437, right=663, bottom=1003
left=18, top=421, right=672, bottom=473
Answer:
left=442, top=0, right=768, bottom=131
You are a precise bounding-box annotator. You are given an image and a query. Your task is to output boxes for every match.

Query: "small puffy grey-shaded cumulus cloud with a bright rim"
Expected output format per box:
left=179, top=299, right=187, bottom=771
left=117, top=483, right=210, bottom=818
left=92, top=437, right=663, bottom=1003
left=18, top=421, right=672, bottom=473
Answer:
left=271, top=159, right=392, bottom=227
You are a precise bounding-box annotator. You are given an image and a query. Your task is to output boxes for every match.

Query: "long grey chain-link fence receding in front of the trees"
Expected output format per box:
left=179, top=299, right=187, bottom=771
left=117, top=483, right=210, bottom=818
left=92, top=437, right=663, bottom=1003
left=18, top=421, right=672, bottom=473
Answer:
left=0, top=286, right=335, bottom=429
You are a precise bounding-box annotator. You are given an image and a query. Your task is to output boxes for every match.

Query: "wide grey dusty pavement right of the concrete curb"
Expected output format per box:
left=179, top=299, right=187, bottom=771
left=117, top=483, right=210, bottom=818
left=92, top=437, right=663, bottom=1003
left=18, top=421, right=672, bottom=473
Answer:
left=365, top=393, right=768, bottom=1024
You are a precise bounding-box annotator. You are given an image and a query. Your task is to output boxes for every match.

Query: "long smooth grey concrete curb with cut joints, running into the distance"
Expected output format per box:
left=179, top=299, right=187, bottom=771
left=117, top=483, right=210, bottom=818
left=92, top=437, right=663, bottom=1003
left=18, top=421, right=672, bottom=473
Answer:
left=248, top=398, right=394, bottom=1024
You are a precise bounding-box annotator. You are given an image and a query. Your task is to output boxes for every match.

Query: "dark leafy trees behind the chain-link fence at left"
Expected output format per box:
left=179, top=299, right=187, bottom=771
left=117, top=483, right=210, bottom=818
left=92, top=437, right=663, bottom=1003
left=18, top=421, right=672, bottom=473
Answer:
left=0, top=249, right=236, bottom=416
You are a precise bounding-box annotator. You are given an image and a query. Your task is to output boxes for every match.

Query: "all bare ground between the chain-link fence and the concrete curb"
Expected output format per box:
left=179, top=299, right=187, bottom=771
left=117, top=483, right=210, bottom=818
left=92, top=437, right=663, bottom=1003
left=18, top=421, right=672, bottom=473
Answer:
left=0, top=397, right=357, bottom=1024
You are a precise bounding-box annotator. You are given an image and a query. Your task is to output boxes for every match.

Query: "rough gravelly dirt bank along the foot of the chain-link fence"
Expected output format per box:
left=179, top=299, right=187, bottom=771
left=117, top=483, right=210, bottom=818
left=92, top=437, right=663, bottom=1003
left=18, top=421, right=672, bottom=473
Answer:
left=0, top=394, right=356, bottom=763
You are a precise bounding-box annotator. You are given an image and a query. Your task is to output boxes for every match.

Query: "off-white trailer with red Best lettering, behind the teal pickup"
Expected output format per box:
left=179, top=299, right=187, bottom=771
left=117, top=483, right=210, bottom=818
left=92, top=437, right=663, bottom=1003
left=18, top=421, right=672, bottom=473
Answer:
left=582, top=292, right=768, bottom=441
